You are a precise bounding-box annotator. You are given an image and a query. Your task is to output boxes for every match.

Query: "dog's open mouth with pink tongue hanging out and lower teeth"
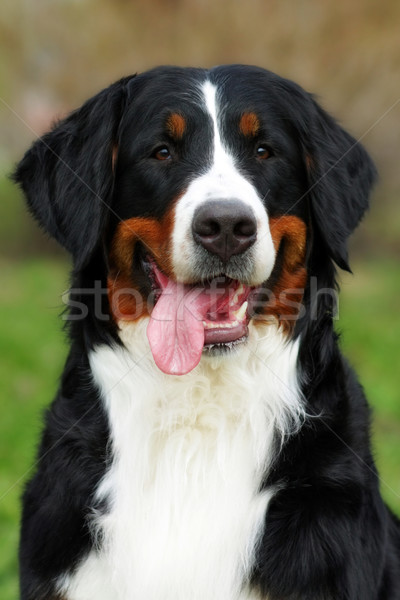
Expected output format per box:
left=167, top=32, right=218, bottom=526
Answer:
left=143, top=259, right=254, bottom=375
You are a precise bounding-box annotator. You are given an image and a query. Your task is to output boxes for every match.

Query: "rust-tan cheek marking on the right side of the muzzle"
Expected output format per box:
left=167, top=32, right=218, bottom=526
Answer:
left=258, top=216, right=307, bottom=331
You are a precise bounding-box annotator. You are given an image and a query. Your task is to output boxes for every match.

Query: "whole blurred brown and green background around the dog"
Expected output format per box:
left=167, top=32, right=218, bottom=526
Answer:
left=0, top=0, right=400, bottom=600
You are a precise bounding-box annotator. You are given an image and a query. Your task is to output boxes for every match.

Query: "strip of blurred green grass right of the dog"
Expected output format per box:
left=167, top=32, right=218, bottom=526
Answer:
left=338, top=259, right=400, bottom=514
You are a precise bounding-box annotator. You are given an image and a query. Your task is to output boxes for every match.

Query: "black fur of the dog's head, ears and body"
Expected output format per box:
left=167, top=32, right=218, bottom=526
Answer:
left=15, top=66, right=400, bottom=600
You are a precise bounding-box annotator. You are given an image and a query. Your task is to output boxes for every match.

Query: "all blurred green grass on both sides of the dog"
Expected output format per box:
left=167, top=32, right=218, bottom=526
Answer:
left=0, top=259, right=400, bottom=600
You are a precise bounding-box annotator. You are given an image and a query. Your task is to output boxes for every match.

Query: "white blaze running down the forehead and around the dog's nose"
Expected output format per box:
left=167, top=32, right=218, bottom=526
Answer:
left=172, top=81, right=275, bottom=285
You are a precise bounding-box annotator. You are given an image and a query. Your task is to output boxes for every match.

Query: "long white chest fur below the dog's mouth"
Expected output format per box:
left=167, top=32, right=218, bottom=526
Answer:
left=61, top=321, right=303, bottom=600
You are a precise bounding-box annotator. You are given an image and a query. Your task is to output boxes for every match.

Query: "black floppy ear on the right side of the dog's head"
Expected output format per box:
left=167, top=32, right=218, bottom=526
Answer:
left=302, top=97, right=376, bottom=271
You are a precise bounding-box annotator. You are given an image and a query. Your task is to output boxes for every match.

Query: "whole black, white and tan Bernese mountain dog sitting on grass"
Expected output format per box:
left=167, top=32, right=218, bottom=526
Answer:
left=14, top=65, right=400, bottom=600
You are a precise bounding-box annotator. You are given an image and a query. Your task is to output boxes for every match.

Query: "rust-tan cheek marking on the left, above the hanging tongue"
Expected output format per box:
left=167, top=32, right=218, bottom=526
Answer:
left=108, top=209, right=175, bottom=321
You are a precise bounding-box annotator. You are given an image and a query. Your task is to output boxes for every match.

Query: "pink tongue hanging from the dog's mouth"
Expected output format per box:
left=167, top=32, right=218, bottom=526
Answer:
left=147, top=280, right=212, bottom=375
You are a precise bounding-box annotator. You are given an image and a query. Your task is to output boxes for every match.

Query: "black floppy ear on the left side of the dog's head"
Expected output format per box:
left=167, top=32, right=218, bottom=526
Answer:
left=13, top=77, right=131, bottom=268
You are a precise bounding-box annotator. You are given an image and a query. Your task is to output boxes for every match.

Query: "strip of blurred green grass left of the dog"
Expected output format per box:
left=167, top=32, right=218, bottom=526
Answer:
left=0, top=260, right=67, bottom=600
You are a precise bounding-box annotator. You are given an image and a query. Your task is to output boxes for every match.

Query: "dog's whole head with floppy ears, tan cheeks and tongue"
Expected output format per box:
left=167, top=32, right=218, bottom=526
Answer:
left=16, top=66, right=374, bottom=374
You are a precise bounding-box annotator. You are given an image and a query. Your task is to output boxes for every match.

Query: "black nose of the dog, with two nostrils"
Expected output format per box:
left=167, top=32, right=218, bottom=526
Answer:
left=192, top=200, right=257, bottom=262
